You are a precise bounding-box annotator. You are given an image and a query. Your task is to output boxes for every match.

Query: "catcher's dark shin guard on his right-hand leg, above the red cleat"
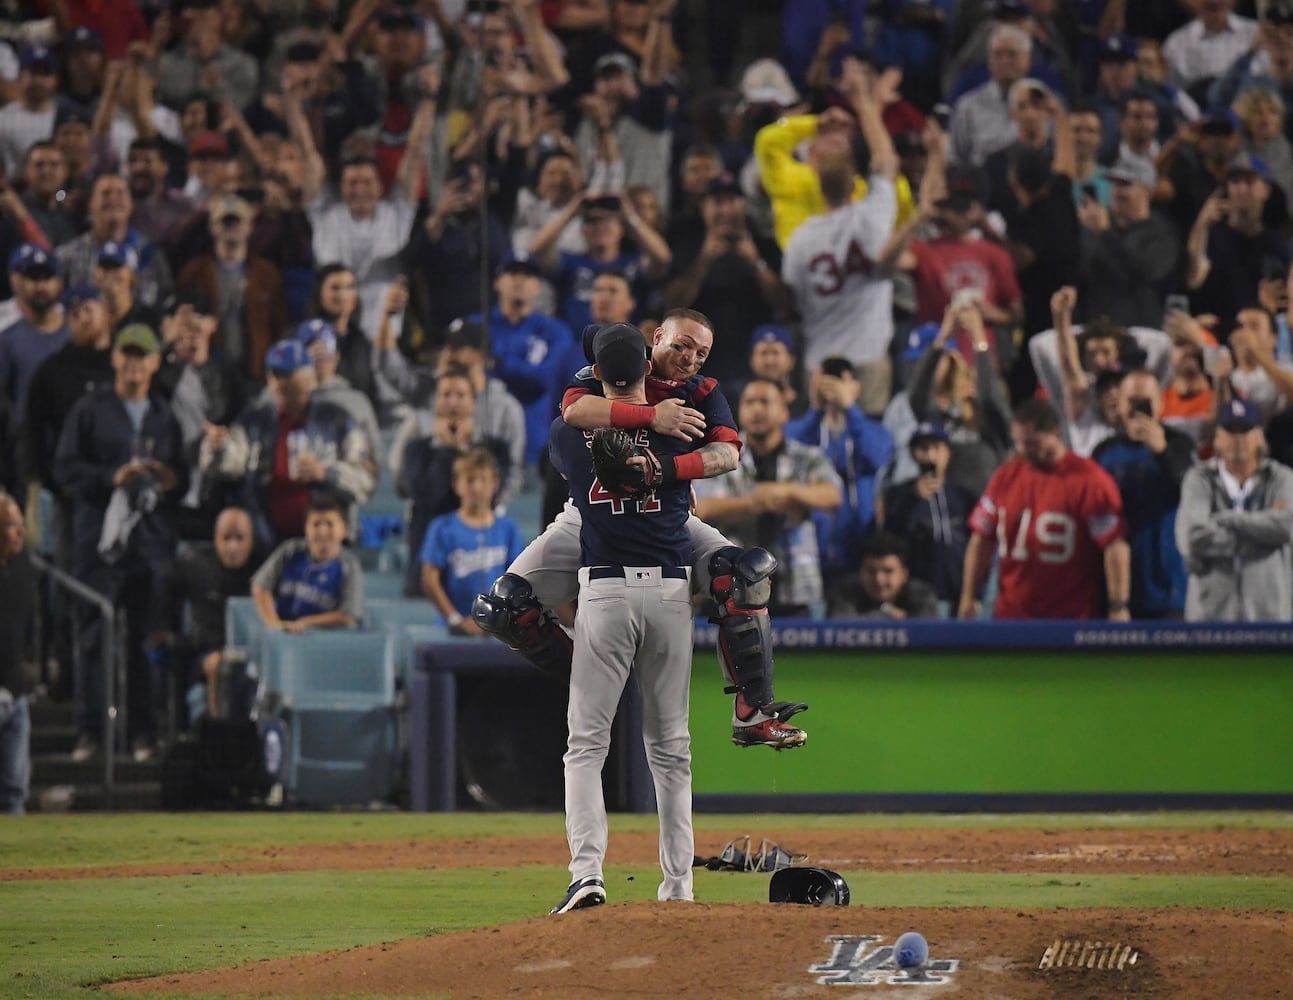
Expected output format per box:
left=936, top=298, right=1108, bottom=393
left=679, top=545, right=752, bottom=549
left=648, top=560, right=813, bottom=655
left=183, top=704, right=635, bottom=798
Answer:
left=710, top=546, right=777, bottom=708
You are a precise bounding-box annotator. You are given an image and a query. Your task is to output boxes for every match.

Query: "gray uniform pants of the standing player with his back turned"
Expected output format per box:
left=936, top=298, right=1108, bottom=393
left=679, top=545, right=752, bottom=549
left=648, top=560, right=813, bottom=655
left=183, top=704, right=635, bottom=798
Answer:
left=564, top=567, right=696, bottom=899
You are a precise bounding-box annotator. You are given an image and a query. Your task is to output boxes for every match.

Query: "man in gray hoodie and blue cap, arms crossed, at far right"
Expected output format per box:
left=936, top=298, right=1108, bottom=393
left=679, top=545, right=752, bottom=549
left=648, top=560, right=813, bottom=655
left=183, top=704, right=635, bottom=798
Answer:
left=1177, top=398, right=1293, bottom=621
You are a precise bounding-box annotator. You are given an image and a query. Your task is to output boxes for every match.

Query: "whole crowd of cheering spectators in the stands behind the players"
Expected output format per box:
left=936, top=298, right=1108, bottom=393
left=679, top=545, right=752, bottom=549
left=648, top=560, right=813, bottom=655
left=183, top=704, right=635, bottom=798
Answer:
left=0, top=0, right=1293, bottom=802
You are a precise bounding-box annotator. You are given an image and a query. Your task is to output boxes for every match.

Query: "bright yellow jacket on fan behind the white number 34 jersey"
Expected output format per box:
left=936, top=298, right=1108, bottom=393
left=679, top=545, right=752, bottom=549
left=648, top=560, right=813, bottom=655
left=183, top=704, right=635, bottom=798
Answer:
left=754, top=115, right=915, bottom=250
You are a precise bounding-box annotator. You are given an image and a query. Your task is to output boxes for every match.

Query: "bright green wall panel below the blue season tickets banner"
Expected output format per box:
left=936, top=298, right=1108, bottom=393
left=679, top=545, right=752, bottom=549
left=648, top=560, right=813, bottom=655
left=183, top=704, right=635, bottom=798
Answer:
left=692, top=647, right=1293, bottom=797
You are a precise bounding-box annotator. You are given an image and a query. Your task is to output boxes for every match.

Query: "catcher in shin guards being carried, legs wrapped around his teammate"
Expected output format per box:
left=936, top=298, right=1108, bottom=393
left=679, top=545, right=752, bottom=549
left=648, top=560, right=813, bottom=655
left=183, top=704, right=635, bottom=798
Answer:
left=472, top=309, right=807, bottom=749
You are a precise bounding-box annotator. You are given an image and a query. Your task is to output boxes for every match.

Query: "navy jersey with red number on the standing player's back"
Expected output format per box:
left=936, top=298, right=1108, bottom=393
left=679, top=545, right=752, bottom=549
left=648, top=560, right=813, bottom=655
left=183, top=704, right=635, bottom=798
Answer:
left=548, top=417, right=697, bottom=567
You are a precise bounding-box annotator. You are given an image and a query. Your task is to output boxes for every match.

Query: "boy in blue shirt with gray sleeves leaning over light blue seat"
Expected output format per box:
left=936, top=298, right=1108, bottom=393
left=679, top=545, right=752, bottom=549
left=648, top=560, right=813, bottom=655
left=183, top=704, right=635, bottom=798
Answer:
left=251, top=493, right=363, bottom=633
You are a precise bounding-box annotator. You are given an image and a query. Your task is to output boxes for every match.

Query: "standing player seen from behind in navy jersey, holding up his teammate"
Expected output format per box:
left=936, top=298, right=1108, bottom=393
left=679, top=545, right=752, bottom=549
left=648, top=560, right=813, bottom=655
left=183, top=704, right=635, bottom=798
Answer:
left=550, top=323, right=696, bottom=913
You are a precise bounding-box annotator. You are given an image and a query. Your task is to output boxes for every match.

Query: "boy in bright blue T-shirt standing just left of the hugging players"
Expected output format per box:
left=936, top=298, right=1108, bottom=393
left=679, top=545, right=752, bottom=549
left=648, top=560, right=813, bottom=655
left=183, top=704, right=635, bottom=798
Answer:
left=420, top=448, right=525, bottom=635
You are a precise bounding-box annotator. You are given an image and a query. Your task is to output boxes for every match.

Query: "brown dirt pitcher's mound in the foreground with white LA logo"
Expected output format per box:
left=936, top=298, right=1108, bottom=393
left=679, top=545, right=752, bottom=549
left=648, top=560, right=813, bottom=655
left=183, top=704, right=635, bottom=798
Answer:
left=110, top=903, right=1293, bottom=1000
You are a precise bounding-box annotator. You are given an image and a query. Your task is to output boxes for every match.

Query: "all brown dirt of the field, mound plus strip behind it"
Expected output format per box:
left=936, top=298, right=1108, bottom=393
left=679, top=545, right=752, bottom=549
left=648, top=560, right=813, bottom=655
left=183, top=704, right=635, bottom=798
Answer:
left=88, top=829, right=1293, bottom=1000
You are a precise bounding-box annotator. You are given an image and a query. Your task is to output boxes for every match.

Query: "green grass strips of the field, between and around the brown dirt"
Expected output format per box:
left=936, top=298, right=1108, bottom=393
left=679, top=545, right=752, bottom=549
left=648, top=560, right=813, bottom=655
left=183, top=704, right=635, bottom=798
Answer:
left=0, top=814, right=1293, bottom=1000
